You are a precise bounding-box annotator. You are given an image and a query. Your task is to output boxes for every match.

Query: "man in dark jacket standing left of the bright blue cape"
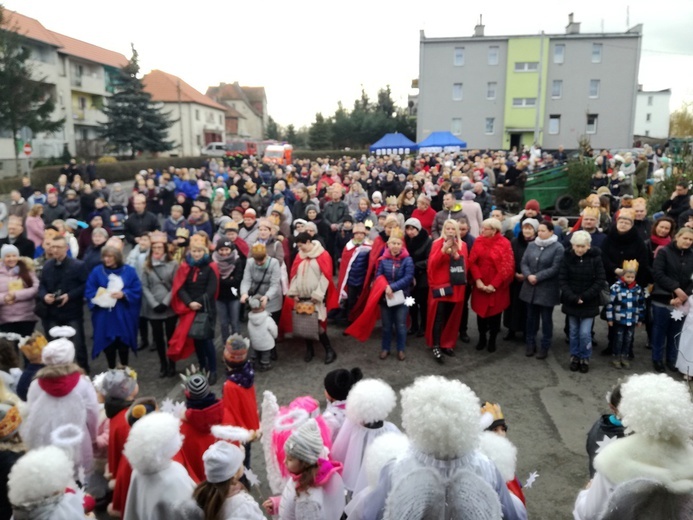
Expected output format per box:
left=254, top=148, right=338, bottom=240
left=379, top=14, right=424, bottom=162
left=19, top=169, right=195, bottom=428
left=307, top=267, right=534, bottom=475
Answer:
left=37, top=237, right=89, bottom=373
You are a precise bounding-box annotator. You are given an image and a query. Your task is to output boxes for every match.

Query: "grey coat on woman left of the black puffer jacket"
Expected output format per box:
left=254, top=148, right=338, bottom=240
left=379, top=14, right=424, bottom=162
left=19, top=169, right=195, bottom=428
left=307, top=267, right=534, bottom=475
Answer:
left=520, top=241, right=563, bottom=307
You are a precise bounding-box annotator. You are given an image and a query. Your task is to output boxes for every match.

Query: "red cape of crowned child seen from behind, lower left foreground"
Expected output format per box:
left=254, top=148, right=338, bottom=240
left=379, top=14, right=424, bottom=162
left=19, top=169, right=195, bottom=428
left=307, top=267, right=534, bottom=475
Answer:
left=180, top=400, right=224, bottom=483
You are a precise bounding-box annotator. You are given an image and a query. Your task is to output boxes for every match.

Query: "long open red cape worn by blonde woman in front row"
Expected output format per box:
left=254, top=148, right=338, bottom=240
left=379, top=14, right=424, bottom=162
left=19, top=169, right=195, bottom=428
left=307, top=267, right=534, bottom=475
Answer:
left=426, top=237, right=469, bottom=348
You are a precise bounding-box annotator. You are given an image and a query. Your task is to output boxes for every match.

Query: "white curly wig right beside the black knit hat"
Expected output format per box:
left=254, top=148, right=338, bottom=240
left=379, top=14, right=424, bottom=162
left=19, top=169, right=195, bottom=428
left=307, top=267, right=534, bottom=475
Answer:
left=346, top=379, right=397, bottom=425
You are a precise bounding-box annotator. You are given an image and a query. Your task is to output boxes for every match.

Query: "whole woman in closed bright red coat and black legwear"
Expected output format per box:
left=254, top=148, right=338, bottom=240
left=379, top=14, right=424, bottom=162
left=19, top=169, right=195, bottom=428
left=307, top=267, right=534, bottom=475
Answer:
left=469, top=218, right=515, bottom=352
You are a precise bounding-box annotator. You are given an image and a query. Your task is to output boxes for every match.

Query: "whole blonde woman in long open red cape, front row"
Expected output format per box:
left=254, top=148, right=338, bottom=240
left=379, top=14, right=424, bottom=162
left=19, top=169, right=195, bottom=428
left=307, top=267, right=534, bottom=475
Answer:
left=426, top=219, right=467, bottom=363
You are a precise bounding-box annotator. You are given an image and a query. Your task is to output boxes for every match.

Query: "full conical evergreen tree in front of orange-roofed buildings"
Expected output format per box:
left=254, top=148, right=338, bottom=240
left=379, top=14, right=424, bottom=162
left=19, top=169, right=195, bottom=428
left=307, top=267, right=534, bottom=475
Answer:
left=101, top=45, right=175, bottom=159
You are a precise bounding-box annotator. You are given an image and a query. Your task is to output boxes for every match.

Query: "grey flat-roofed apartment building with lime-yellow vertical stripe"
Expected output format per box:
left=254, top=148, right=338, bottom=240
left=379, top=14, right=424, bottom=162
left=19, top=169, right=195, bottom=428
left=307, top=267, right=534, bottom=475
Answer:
left=417, top=14, right=642, bottom=149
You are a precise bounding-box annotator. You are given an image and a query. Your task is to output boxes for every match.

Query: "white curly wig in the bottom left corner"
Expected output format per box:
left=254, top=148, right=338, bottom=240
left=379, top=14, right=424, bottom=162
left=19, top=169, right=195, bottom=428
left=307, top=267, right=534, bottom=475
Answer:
left=7, top=446, right=72, bottom=507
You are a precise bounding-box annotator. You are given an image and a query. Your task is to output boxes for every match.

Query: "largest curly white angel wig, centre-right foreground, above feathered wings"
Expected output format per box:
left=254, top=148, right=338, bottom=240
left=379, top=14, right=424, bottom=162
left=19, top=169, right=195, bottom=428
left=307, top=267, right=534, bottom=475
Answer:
left=400, top=376, right=481, bottom=459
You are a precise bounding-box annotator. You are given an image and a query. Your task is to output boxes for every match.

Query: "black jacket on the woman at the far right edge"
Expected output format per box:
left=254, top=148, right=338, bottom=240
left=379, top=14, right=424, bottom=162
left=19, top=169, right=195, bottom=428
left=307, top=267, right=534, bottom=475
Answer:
left=652, top=241, right=693, bottom=305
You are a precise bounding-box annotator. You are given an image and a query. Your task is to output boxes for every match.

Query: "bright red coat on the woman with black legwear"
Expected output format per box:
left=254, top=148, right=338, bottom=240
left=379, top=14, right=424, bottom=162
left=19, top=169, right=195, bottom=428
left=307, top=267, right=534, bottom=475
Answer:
left=468, top=233, right=515, bottom=318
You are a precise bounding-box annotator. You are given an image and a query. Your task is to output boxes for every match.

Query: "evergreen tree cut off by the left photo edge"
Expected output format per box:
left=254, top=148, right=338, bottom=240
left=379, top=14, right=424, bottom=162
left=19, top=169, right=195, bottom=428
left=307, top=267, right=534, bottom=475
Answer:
left=0, top=5, right=65, bottom=175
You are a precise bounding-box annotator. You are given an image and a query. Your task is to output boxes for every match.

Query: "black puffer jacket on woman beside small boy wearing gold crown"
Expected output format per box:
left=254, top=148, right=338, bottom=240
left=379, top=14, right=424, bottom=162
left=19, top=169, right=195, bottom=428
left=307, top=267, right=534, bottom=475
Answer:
left=558, top=248, right=606, bottom=318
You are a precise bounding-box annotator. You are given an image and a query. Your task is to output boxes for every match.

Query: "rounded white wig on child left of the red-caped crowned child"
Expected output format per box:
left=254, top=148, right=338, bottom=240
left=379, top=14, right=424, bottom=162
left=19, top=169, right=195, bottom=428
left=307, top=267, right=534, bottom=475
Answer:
left=123, top=412, right=183, bottom=475
